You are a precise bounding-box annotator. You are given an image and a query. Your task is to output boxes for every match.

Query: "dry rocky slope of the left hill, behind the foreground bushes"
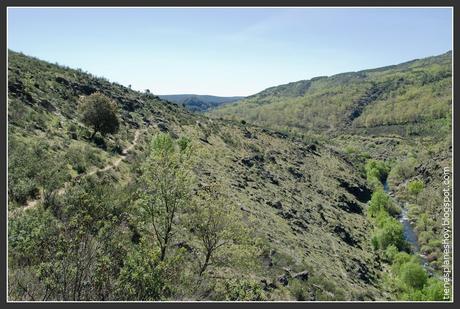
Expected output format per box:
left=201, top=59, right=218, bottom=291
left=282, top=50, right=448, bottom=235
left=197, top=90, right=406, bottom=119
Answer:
left=8, top=51, right=387, bottom=300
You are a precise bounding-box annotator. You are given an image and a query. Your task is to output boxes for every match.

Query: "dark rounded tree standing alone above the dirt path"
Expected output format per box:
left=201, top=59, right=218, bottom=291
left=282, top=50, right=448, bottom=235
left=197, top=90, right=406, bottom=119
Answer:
left=78, top=92, right=120, bottom=139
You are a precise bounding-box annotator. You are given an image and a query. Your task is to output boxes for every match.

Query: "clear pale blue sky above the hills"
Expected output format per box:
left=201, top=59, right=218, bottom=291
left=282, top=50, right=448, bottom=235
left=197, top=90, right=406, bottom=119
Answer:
left=8, top=8, right=452, bottom=96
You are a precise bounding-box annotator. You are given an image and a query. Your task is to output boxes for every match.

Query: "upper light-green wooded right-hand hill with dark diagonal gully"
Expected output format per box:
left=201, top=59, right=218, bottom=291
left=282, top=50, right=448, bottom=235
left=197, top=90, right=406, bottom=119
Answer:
left=210, top=51, right=452, bottom=134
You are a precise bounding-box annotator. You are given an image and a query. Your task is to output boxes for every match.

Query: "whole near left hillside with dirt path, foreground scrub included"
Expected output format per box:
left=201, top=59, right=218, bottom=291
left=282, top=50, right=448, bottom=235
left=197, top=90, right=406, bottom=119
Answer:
left=8, top=51, right=392, bottom=300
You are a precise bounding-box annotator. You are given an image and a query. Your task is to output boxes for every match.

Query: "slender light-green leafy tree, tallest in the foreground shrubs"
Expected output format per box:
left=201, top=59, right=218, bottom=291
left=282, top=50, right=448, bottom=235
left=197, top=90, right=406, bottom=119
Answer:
left=138, top=133, right=194, bottom=261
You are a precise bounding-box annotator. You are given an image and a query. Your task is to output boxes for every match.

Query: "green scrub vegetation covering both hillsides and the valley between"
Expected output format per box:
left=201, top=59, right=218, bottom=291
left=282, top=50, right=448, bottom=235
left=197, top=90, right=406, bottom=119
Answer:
left=8, top=51, right=451, bottom=300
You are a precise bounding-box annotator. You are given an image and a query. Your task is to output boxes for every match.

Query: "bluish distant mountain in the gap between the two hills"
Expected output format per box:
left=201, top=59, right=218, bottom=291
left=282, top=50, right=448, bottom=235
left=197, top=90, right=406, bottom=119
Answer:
left=160, top=94, right=244, bottom=112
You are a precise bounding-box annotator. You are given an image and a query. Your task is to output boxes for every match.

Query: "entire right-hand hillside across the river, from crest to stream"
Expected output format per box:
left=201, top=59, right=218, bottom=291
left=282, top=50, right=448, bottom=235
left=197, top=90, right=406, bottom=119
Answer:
left=208, top=52, right=453, bottom=300
